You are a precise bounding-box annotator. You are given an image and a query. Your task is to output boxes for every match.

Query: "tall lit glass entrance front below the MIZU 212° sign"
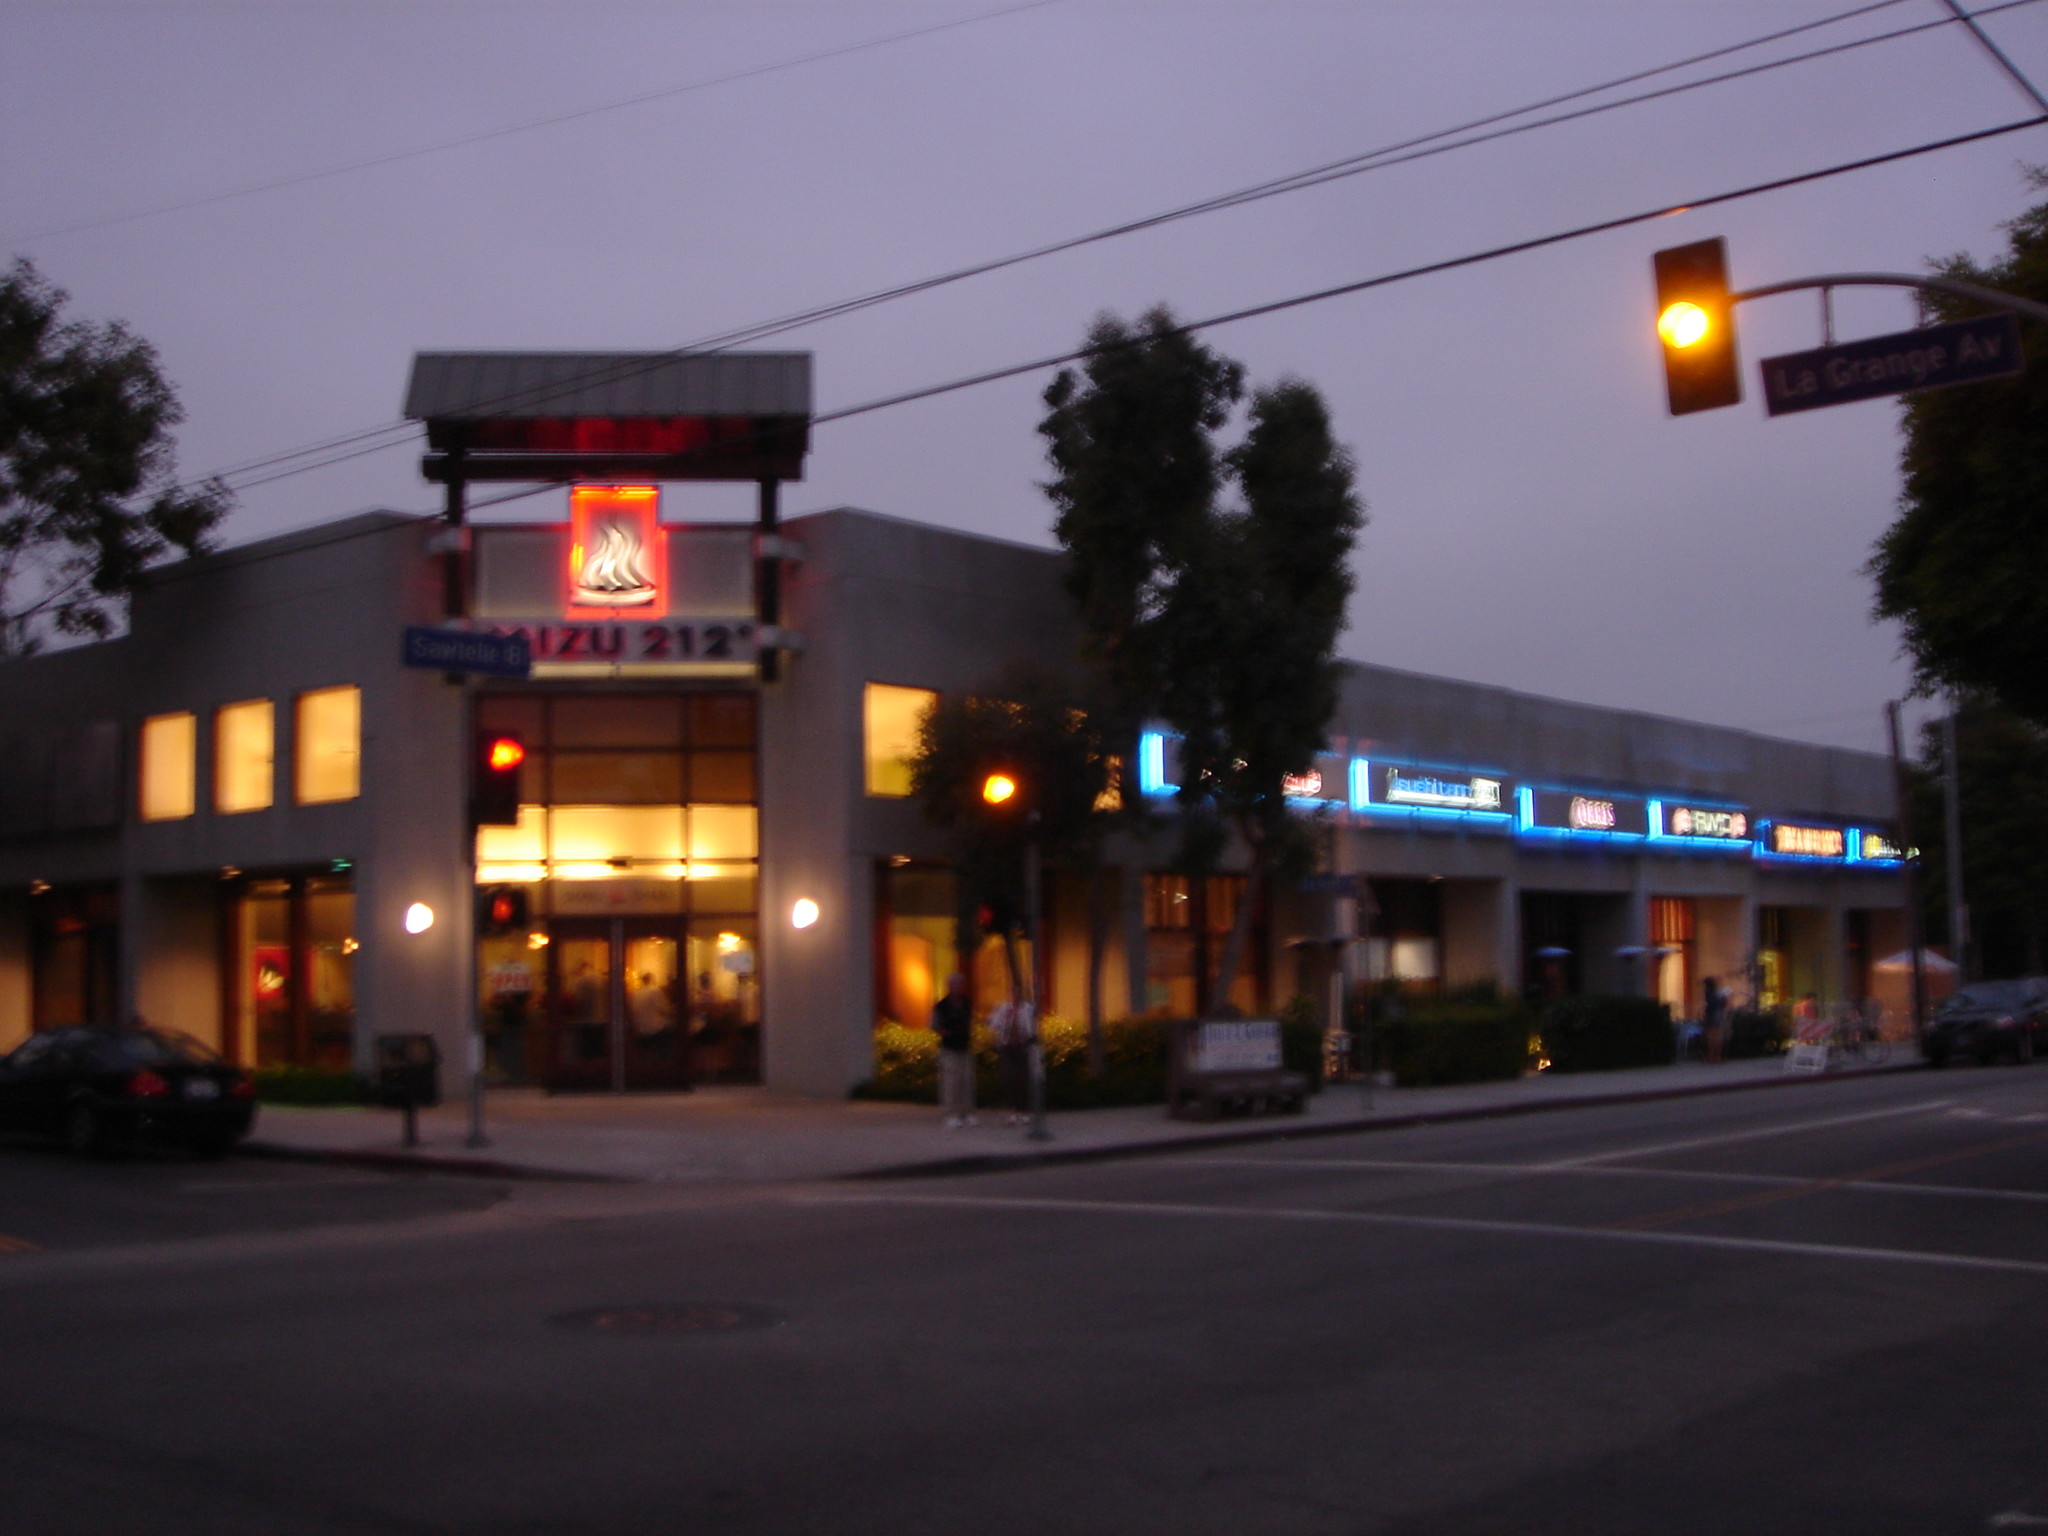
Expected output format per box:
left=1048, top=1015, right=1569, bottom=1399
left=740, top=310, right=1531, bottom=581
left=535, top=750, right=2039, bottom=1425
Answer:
left=477, top=690, right=760, bottom=1090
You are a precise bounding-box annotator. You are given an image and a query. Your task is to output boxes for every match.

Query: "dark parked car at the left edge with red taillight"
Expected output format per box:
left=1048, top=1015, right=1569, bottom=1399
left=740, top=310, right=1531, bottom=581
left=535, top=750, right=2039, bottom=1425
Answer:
left=0, top=1024, right=256, bottom=1157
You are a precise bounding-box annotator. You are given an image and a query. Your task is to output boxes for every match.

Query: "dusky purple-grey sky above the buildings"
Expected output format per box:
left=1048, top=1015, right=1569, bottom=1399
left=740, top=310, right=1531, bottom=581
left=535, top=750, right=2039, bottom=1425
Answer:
left=0, top=0, right=2048, bottom=750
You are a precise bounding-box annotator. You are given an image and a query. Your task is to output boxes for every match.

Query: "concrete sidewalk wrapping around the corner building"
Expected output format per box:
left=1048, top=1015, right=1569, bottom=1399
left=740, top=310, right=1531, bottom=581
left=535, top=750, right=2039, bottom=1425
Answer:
left=244, top=1047, right=1919, bottom=1184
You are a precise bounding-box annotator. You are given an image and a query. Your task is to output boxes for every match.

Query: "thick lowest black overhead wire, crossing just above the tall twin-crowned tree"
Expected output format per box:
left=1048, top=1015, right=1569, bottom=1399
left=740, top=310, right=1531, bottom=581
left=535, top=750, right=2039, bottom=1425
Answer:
left=415, top=115, right=2048, bottom=524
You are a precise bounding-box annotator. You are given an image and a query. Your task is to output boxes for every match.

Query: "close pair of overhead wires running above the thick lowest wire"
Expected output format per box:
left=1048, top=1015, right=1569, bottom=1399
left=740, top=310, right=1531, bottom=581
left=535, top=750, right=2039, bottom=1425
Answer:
left=199, top=0, right=2007, bottom=499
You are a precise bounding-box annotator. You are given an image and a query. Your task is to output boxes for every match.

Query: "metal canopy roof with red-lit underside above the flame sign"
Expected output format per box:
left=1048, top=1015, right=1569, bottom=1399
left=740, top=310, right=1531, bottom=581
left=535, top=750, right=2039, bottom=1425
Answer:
left=406, top=352, right=811, bottom=481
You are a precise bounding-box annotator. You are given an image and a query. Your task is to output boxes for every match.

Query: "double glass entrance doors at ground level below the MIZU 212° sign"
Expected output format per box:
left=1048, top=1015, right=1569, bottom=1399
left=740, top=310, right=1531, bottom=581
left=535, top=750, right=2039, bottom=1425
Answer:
left=545, top=918, right=690, bottom=1094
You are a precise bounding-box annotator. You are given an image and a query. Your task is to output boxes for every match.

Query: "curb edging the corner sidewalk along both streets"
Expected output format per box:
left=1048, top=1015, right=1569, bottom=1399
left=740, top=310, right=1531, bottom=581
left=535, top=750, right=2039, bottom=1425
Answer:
left=236, top=1061, right=1925, bottom=1184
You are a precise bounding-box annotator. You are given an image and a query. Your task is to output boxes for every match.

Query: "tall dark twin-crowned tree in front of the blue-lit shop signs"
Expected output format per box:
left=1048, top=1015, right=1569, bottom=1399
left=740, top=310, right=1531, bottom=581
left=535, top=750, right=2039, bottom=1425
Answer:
left=1038, top=307, right=1364, bottom=1006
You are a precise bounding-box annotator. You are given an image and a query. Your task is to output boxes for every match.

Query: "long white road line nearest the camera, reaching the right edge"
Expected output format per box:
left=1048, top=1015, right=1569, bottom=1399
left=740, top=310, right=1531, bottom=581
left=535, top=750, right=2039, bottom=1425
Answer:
left=795, top=1190, right=2048, bottom=1276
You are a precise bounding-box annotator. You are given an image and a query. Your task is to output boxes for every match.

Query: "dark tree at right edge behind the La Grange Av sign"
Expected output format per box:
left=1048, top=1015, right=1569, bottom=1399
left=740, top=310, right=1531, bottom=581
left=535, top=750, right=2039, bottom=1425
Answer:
left=1868, top=172, right=2048, bottom=725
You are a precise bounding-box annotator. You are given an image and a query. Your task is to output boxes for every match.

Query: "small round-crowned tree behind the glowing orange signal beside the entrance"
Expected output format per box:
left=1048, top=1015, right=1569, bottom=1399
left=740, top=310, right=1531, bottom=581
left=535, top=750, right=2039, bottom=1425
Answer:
left=911, top=668, right=1110, bottom=1001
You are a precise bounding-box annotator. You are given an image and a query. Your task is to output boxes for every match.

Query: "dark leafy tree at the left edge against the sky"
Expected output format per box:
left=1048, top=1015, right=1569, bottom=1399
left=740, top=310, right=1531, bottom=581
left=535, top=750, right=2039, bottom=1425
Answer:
left=0, top=260, right=229, bottom=659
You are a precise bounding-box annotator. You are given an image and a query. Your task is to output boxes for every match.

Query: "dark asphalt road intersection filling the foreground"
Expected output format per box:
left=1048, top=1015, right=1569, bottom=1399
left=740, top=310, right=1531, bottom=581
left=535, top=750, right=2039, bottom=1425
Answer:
left=0, top=1065, right=2048, bottom=1536
